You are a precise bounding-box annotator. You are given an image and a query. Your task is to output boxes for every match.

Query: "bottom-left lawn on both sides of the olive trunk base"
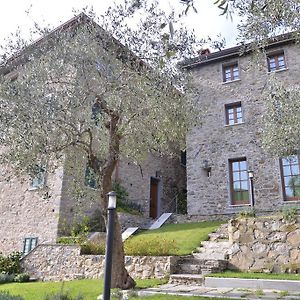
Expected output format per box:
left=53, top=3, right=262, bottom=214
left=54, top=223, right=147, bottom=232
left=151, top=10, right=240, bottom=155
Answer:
left=0, top=279, right=166, bottom=300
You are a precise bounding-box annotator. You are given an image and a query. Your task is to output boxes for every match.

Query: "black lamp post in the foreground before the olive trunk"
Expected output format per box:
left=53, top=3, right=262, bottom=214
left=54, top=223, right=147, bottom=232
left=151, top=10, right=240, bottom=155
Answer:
left=103, top=192, right=117, bottom=300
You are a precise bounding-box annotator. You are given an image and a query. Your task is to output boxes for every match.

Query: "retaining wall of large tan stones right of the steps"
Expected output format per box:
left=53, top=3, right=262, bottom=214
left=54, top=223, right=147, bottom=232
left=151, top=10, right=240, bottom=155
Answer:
left=228, top=217, right=300, bottom=273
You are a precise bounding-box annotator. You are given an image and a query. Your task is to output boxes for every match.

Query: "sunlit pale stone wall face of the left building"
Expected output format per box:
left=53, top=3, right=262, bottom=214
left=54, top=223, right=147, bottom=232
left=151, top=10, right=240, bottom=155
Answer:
left=0, top=166, right=63, bottom=254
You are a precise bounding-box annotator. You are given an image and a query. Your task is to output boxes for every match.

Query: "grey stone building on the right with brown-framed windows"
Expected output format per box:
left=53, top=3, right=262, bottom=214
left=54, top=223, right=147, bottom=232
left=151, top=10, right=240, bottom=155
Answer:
left=183, top=34, right=300, bottom=216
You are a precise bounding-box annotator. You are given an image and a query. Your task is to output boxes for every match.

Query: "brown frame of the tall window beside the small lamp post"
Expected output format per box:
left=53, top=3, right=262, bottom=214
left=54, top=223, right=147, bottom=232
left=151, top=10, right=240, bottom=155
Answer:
left=228, top=156, right=250, bottom=206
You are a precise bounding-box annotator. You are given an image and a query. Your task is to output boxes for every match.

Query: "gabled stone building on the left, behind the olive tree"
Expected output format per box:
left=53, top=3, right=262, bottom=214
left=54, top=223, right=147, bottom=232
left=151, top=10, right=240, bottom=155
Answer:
left=0, top=14, right=185, bottom=254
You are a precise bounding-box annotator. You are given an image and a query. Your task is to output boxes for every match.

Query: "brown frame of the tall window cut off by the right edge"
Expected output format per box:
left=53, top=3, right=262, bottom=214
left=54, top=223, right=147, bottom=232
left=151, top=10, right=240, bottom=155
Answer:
left=279, top=155, right=300, bottom=202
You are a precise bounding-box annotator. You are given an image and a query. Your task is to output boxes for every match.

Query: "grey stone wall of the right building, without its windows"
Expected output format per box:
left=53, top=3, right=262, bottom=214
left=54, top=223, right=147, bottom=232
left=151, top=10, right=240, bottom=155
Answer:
left=187, top=44, right=300, bottom=215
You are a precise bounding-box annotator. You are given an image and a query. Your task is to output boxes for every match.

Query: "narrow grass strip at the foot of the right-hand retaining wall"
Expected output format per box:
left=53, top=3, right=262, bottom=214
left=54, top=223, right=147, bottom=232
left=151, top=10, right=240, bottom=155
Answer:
left=207, top=271, right=300, bottom=280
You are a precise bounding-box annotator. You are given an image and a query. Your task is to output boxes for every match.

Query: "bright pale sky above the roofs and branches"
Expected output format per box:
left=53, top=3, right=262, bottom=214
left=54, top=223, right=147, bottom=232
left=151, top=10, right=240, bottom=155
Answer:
left=0, top=0, right=237, bottom=47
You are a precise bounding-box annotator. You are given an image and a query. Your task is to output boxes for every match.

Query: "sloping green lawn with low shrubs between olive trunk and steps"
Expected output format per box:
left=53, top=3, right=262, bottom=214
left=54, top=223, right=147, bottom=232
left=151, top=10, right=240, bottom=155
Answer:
left=125, top=221, right=222, bottom=255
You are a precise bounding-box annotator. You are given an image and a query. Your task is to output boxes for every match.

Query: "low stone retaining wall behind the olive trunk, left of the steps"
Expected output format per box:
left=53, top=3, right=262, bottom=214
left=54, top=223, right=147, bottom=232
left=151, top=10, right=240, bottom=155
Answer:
left=22, top=244, right=177, bottom=281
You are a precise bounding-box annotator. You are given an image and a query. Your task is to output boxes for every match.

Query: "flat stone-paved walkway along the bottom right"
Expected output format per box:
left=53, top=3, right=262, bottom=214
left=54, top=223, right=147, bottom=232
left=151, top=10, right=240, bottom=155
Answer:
left=138, top=284, right=300, bottom=300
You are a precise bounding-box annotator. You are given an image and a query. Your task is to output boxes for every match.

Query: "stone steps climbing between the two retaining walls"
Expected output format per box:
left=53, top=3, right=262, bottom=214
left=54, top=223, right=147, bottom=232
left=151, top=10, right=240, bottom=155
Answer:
left=169, top=224, right=231, bottom=284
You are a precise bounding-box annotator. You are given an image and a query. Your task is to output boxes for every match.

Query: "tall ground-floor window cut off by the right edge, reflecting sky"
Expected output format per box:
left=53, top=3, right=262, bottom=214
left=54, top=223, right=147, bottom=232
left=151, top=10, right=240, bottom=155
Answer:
left=280, top=155, right=300, bottom=200
